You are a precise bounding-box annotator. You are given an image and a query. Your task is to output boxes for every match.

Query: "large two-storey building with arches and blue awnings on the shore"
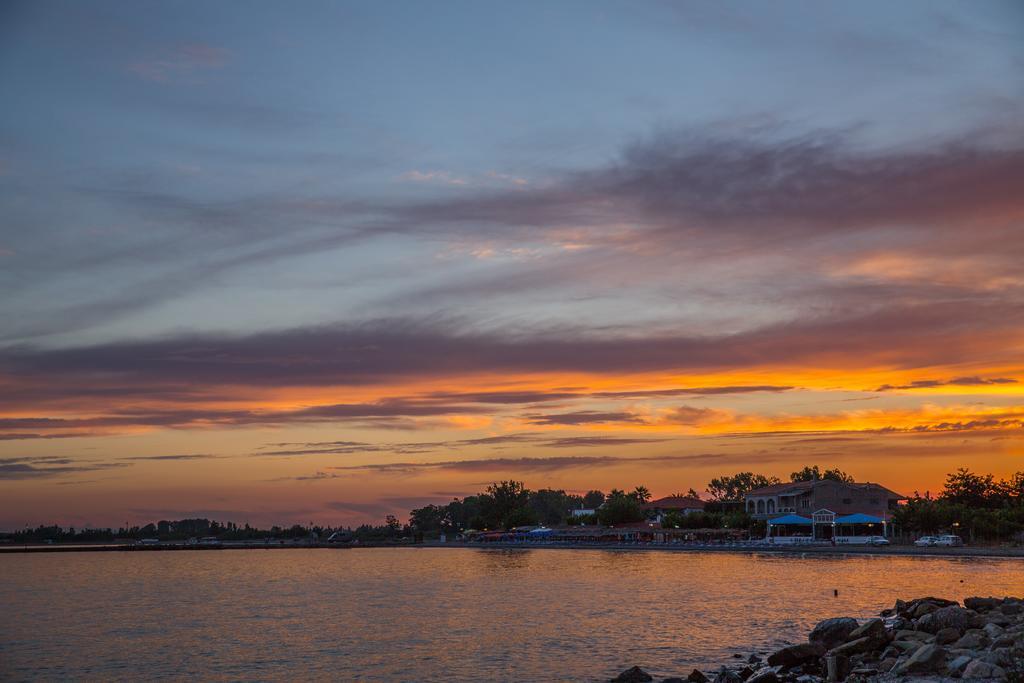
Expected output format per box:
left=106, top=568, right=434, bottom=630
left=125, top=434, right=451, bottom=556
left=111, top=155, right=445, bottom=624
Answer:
left=743, top=479, right=905, bottom=543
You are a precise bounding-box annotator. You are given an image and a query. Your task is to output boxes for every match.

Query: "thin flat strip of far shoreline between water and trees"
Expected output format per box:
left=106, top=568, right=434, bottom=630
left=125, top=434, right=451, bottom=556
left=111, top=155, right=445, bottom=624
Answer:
left=0, top=541, right=1024, bottom=559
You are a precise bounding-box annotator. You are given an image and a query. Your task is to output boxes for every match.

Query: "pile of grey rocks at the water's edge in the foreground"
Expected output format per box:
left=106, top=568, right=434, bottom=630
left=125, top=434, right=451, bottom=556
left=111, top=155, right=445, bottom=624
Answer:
left=611, top=597, right=1024, bottom=683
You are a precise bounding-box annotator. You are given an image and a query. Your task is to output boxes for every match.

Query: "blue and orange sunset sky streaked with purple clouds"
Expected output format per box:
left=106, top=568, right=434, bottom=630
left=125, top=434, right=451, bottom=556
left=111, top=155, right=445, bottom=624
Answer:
left=0, top=0, right=1024, bottom=529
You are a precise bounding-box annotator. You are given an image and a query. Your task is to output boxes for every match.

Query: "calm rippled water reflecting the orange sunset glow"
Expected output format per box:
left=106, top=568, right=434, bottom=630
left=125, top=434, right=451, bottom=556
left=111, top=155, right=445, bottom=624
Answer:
left=0, top=548, right=1024, bottom=681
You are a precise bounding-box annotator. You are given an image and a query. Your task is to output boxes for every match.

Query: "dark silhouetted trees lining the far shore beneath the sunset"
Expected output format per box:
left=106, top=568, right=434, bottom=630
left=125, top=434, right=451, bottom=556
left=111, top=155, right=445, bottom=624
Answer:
left=9, top=465, right=1024, bottom=543
